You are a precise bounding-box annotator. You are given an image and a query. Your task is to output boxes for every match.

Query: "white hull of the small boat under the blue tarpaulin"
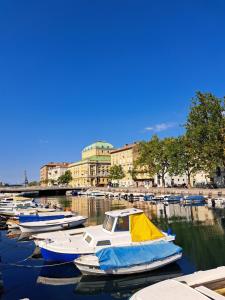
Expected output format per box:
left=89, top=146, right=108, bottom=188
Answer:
left=74, top=253, right=182, bottom=276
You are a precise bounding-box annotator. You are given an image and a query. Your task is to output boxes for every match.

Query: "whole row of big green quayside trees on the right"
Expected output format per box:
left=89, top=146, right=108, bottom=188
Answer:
left=136, top=92, right=225, bottom=186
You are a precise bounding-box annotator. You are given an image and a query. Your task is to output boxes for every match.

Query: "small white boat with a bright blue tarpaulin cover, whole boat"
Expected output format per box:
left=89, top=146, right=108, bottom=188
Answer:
left=74, top=241, right=182, bottom=275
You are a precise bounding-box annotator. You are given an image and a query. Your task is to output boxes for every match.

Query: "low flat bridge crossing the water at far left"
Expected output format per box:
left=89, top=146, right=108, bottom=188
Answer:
left=0, top=186, right=82, bottom=196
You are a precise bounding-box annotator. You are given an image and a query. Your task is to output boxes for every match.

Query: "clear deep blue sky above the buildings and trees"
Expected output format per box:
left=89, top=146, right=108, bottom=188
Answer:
left=0, top=0, right=225, bottom=183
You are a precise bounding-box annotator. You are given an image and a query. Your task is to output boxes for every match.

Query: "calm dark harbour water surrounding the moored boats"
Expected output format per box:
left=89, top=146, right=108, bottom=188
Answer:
left=0, top=197, right=225, bottom=300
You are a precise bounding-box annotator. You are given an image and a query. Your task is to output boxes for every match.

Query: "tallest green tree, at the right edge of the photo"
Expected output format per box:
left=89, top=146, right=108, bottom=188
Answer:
left=185, top=92, right=225, bottom=174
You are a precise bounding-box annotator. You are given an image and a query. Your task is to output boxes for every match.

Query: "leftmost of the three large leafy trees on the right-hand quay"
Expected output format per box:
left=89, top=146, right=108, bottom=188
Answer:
left=137, top=135, right=174, bottom=187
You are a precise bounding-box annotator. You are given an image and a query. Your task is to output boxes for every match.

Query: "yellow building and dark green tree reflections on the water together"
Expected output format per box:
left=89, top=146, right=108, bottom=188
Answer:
left=33, top=197, right=225, bottom=270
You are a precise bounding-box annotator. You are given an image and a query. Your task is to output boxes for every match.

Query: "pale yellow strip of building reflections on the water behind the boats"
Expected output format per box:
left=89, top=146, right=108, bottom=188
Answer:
left=41, top=197, right=225, bottom=225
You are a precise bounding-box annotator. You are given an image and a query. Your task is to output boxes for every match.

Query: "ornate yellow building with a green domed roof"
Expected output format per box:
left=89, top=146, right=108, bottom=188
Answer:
left=68, top=141, right=113, bottom=187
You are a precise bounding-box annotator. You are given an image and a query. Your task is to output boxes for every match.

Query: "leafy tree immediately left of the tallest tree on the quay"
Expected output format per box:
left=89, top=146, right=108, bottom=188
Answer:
left=168, top=135, right=201, bottom=187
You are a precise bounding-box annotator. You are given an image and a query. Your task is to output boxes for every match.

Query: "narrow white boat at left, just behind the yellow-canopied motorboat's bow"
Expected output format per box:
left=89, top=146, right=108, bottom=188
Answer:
left=19, top=216, right=87, bottom=233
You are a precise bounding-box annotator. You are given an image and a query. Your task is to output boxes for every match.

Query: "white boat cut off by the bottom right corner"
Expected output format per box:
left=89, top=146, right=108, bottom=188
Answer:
left=130, top=266, right=225, bottom=300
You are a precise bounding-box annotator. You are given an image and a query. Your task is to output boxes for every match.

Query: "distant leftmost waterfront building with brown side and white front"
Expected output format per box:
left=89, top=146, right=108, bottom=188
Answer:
left=40, top=162, right=69, bottom=186
